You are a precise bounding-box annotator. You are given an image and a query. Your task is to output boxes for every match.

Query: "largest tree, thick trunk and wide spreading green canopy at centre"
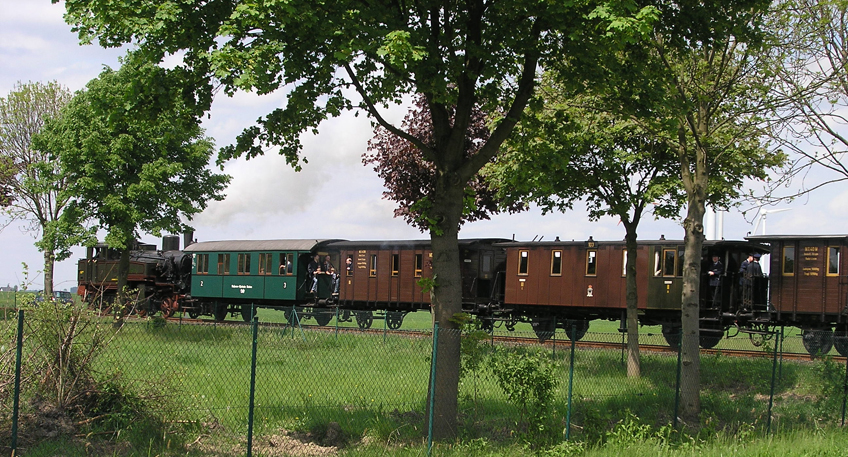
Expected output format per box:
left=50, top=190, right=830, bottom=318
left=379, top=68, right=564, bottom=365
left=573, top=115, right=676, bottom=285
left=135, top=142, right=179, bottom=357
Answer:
left=58, top=0, right=654, bottom=439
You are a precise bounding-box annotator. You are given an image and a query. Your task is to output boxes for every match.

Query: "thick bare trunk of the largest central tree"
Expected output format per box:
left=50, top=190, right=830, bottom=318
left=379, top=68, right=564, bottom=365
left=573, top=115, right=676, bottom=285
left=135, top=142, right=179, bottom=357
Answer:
left=428, top=177, right=463, bottom=440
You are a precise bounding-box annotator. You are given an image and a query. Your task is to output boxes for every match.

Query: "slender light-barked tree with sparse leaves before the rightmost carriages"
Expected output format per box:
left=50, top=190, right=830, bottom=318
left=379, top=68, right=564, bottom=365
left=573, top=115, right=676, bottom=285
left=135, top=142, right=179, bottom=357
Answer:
left=584, top=1, right=785, bottom=423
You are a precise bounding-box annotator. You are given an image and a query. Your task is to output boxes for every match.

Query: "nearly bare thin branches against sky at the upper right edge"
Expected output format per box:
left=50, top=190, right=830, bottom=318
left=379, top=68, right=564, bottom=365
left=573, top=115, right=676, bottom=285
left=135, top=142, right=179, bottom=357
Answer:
left=761, top=0, right=848, bottom=202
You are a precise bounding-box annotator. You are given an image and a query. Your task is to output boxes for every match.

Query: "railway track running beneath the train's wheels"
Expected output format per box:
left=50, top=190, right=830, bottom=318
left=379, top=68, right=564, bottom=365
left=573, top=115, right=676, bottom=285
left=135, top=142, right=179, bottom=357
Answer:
left=157, top=317, right=846, bottom=363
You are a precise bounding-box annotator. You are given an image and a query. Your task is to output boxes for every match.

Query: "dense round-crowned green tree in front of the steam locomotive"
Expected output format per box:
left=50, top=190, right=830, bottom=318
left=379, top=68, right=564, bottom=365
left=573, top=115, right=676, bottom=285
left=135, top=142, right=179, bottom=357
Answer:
left=33, top=56, right=229, bottom=310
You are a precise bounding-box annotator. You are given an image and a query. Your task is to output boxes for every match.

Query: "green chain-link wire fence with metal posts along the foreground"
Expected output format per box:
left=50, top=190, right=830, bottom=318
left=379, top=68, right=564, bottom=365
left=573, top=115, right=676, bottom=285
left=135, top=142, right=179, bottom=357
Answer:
left=0, top=307, right=848, bottom=455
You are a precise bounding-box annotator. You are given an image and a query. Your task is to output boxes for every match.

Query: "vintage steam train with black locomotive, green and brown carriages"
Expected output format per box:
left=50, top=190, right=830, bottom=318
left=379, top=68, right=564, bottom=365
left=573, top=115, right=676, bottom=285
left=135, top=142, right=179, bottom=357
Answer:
left=78, top=235, right=848, bottom=355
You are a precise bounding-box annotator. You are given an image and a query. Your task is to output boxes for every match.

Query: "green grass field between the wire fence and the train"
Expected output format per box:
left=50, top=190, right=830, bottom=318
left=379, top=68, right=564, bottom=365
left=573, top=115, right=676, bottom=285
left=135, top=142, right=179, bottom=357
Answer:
left=3, top=302, right=845, bottom=455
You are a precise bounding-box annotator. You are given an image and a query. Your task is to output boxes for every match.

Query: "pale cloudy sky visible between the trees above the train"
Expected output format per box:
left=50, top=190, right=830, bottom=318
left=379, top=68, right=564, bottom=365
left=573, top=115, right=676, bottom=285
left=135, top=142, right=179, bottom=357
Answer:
left=0, top=0, right=848, bottom=290
